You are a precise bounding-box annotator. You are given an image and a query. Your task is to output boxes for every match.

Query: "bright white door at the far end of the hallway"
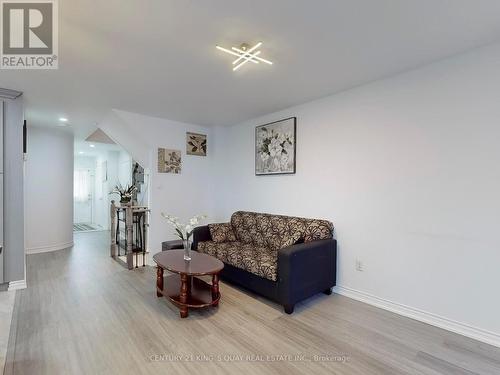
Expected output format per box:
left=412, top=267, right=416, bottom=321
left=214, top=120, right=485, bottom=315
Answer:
left=73, top=169, right=94, bottom=223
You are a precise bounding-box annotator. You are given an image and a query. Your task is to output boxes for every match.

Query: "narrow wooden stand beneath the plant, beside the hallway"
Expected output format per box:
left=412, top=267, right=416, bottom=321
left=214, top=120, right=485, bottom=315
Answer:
left=110, top=201, right=150, bottom=270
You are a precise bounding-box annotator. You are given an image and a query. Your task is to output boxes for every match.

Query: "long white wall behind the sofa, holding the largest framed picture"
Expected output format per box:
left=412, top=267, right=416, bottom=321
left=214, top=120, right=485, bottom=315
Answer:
left=213, top=45, right=500, bottom=344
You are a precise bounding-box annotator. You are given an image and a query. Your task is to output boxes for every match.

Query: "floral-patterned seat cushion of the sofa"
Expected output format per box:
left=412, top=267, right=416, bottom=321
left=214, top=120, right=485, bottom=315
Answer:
left=198, top=241, right=278, bottom=281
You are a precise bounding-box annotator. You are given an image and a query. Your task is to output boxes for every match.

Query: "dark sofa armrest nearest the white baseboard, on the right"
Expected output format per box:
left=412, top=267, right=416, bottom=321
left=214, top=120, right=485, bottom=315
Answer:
left=278, top=239, right=337, bottom=305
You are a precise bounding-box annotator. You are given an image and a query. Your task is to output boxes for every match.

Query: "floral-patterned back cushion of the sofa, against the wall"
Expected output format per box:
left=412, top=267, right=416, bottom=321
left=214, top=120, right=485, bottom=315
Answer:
left=231, top=211, right=333, bottom=250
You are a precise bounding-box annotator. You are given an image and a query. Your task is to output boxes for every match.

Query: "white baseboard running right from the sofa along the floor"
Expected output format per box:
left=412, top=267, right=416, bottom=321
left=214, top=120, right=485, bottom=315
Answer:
left=333, top=286, right=500, bottom=347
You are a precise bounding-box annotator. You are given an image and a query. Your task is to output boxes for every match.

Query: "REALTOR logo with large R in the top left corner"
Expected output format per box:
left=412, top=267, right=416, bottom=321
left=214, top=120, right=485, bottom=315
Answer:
left=0, top=0, right=58, bottom=69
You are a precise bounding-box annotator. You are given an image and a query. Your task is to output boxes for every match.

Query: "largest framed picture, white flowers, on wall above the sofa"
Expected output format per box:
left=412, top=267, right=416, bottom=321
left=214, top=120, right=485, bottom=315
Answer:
left=255, top=117, right=297, bottom=176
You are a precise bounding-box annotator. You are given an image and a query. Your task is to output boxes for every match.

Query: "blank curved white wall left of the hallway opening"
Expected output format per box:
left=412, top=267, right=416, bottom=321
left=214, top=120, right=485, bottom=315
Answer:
left=25, top=127, right=73, bottom=253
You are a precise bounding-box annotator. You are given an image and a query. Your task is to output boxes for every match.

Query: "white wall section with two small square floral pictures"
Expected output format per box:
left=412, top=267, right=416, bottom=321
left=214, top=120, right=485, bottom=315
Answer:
left=99, top=110, right=215, bottom=254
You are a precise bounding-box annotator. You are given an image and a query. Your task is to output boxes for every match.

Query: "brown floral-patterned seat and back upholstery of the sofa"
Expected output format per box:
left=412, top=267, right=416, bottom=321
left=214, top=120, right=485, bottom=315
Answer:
left=198, top=211, right=333, bottom=281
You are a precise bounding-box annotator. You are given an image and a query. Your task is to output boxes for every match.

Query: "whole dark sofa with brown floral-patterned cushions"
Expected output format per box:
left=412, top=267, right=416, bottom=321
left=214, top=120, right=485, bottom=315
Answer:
left=193, top=211, right=337, bottom=314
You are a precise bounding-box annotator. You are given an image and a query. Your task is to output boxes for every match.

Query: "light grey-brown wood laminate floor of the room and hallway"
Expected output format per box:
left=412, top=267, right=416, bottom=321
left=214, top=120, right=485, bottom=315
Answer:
left=5, top=232, right=500, bottom=375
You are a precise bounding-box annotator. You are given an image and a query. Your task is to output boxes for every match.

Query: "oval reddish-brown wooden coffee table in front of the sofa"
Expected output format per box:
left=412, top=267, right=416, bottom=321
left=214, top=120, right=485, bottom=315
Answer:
left=153, top=250, right=224, bottom=318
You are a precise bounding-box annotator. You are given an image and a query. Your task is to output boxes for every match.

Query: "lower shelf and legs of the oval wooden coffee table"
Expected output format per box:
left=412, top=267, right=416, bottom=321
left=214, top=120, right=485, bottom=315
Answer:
left=156, top=274, right=220, bottom=318
